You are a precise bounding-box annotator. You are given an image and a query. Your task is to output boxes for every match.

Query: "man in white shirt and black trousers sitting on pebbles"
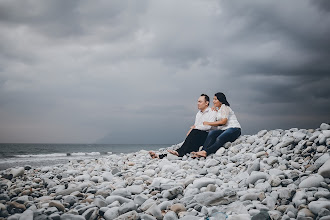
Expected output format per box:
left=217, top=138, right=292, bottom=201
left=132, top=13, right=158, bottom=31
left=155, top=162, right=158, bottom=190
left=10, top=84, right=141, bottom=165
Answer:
left=149, top=94, right=216, bottom=159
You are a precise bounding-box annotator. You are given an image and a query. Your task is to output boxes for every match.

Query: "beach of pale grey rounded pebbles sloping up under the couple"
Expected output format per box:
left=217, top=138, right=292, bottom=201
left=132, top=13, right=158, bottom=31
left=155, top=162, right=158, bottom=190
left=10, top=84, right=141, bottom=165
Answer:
left=0, top=123, right=330, bottom=220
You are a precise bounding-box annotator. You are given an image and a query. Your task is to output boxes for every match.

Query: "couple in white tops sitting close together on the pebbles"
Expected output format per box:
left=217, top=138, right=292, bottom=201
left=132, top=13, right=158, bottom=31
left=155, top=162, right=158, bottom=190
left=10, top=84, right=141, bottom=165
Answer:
left=149, top=92, right=241, bottom=159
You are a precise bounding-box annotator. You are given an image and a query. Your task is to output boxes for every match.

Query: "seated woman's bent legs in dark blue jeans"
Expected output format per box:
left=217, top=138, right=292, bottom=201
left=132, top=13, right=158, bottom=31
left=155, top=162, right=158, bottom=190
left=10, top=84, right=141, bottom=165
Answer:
left=202, top=128, right=241, bottom=155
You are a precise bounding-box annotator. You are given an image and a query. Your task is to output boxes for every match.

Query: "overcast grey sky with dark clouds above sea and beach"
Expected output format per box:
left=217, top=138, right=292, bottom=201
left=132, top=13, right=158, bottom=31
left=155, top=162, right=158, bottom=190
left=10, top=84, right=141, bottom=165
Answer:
left=0, top=0, right=330, bottom=144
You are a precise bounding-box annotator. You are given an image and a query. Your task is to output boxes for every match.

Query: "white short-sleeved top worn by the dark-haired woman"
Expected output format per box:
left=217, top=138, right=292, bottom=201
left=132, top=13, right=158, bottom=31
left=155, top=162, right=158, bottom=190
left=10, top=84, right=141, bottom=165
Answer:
left=217, top=104, right=241, bottom=130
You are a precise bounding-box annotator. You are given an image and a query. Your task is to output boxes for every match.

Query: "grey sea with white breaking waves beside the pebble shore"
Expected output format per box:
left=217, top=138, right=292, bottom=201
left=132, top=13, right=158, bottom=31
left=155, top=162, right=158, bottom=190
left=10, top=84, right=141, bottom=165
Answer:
left=0, top=143, right=172, bottom=170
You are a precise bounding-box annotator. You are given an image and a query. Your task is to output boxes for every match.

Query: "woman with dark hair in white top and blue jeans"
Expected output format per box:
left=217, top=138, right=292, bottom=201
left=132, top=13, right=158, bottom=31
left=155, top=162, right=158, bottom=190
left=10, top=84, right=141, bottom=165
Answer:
left=192, top=92, right=241, bottom=157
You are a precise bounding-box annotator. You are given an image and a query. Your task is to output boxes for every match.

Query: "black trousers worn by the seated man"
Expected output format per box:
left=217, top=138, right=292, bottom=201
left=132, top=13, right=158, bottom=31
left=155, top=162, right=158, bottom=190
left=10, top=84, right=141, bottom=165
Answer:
left=177, top=129, right=207, bottom=157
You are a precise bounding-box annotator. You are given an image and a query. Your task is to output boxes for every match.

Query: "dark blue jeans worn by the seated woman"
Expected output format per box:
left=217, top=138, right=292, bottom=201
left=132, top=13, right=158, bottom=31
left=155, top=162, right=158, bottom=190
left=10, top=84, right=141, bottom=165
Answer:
left=202, top=128, right=241, bottom=155
